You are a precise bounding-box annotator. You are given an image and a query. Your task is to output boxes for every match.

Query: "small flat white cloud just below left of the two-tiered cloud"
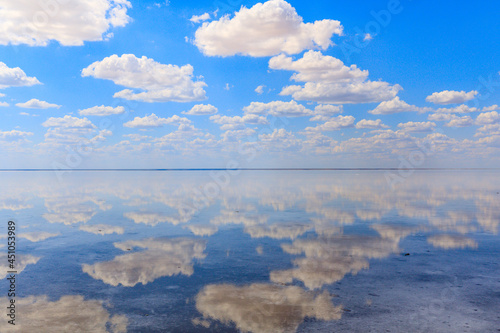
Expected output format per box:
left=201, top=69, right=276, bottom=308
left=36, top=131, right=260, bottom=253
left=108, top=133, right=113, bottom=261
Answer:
left=243, top=101, right=313, bottom=117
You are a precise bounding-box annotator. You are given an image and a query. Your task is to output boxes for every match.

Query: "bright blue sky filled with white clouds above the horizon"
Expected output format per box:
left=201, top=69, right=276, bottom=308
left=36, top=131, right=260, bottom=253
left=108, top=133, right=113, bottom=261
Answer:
left=0, top=0, right=500, bottom=169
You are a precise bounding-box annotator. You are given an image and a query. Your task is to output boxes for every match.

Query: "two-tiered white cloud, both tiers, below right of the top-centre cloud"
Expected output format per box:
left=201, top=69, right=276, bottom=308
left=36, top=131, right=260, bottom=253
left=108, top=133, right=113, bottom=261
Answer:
left=269, top=51, right=402, bottom=104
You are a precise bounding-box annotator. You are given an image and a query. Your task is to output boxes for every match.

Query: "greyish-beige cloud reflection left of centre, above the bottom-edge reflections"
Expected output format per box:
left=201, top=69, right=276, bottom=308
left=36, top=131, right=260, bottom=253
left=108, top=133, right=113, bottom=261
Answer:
left=82, top=238, right=206, bottom=287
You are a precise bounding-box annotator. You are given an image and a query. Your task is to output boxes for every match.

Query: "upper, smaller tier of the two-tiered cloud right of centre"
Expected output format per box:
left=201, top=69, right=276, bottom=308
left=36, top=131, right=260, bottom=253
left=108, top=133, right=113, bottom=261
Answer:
left=269, top=51, right=368, bottom=82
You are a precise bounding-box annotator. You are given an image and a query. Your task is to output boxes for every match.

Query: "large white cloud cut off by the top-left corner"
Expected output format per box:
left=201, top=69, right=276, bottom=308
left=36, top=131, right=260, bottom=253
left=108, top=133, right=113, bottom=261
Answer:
left=0, top=0, right=132, bottom=46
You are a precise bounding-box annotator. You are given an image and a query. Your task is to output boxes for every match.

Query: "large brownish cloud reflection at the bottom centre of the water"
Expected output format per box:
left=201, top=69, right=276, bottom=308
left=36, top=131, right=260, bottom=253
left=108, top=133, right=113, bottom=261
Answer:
left=196, top=283, right=342, bottom=333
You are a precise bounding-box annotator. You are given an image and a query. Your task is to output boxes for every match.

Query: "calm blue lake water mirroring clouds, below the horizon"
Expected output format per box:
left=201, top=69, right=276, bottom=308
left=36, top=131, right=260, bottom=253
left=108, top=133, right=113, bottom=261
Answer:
left=0, top=170, right=500, bottom=333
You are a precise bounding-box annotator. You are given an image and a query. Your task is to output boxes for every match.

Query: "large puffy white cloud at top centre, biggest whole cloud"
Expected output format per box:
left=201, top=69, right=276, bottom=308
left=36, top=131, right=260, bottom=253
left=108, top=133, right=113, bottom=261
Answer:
left=194, top=0, right=342, bottom=57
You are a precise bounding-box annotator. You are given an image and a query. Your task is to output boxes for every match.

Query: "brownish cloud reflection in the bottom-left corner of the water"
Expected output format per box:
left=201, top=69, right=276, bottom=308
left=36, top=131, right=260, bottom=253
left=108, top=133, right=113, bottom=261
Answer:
left=0, top=295, right=128, bottom=333
